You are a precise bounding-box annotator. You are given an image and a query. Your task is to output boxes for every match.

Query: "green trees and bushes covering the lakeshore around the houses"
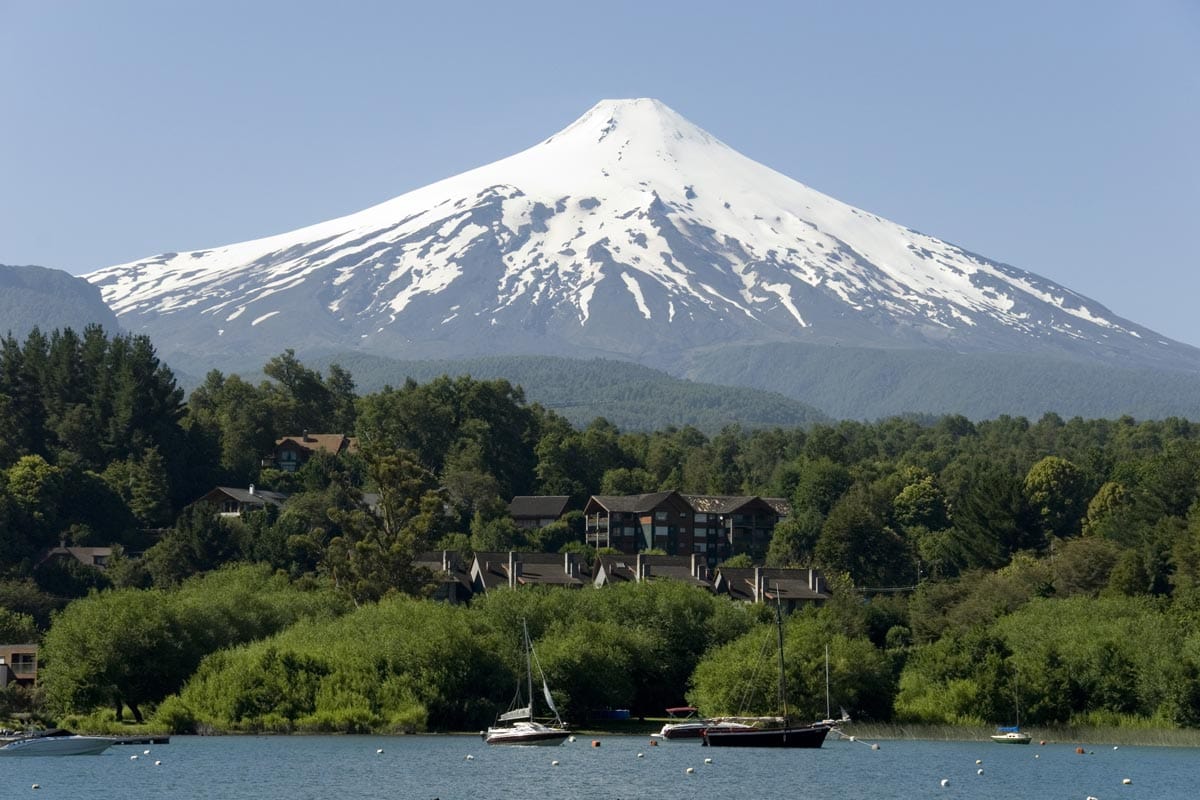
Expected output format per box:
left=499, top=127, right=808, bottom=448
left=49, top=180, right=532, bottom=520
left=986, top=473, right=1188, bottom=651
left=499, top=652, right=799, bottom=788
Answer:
left=0, top=327, right=1200, bottom=732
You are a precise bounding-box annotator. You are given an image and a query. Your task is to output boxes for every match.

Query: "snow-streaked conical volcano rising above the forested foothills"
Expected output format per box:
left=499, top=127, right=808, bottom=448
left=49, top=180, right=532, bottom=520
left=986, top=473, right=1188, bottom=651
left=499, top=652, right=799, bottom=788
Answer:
left=86, top=100, right=1198, bottom=367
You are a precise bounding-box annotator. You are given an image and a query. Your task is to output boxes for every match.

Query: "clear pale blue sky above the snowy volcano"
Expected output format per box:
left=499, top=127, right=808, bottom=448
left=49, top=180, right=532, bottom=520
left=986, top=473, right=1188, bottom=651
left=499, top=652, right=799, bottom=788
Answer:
left=0, top=0, right=1200, bottom=345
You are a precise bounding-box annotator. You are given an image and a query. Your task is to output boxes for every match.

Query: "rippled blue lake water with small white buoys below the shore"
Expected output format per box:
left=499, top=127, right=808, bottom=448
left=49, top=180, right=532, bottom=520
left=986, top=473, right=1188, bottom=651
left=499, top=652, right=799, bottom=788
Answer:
left=0, top=735, right=1200, bottom=800
